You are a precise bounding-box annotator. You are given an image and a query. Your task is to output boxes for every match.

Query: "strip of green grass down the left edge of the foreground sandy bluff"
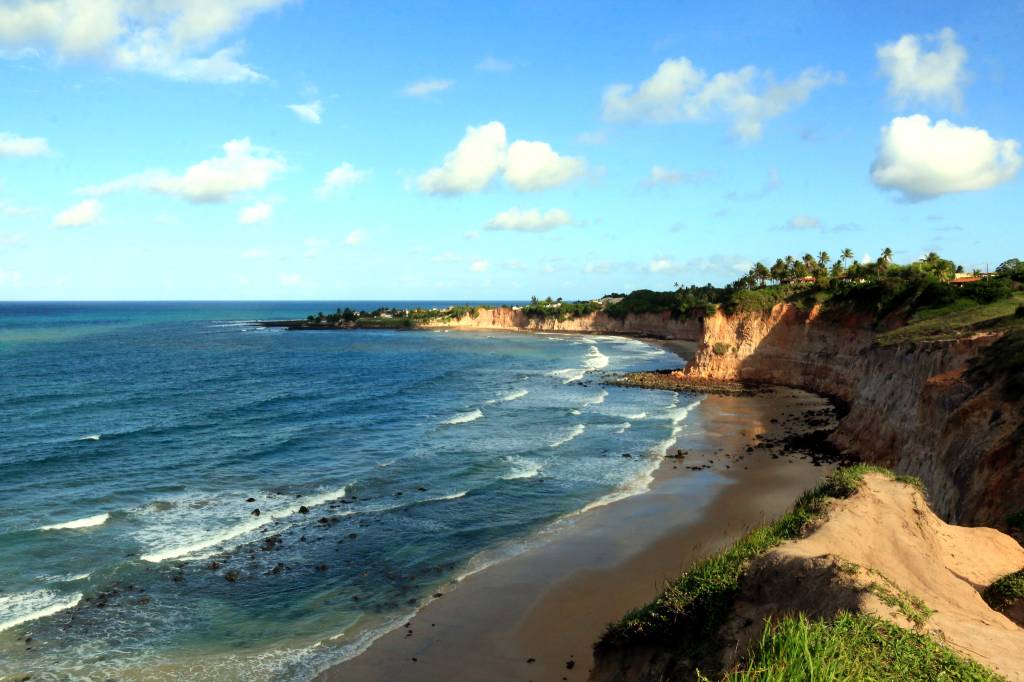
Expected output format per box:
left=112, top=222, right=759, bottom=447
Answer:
left=595, top=464, right=922, bottom=657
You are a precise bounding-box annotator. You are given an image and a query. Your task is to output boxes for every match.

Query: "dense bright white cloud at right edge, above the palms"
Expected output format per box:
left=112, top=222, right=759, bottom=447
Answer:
left=871, top=115, right=1021, bottom=201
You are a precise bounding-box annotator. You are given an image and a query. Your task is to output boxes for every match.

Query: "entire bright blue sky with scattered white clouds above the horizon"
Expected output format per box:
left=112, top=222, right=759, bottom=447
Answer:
left=0, top=0, right=1024, bottom=299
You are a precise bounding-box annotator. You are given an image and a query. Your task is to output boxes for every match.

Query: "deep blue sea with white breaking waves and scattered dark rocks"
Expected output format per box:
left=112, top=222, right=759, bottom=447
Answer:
left=0, top=301, right=692, bottom=680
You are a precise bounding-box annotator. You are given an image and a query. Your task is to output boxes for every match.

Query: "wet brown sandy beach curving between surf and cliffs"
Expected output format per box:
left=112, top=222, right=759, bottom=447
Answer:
left=318, top=376, right=831, bottom=682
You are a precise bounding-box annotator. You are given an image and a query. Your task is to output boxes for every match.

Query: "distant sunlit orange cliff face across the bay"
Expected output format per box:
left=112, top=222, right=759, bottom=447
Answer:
left=431, top=308, right=702, bottom=341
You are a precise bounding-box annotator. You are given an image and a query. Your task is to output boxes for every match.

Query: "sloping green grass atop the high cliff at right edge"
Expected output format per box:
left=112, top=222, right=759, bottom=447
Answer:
left=876, top=293, right=1024, bottom=346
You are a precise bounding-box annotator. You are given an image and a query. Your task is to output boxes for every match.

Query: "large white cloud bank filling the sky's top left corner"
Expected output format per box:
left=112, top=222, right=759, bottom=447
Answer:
left=0, top=0, right=290, bottom=83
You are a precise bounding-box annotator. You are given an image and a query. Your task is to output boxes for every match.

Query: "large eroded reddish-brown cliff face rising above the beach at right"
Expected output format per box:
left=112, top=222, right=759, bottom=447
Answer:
left=681, top=304, right=1024, bottom=525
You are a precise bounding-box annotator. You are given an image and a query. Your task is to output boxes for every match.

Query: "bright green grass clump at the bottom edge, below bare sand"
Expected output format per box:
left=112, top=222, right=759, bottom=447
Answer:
left=720, top=613, right=1004, bottom=682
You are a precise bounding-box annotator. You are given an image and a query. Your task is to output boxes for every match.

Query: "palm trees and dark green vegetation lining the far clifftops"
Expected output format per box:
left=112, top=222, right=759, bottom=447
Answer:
left=296, top=249, right=1024, bottom=346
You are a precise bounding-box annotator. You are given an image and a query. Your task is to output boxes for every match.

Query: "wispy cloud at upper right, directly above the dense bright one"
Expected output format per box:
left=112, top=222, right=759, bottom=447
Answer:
left=876, top=28, right=968, bottom=109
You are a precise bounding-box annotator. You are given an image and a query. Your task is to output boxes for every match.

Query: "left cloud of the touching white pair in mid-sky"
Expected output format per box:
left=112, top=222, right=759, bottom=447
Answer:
left=418, top=121, right=505, bottom=195
